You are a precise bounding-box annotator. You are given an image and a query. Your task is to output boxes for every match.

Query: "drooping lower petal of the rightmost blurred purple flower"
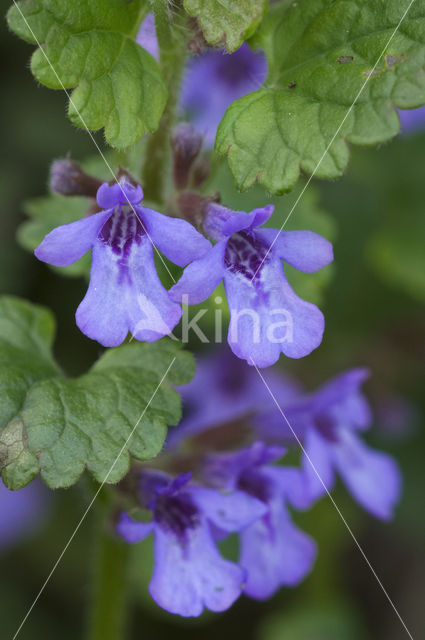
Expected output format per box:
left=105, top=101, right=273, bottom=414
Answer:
left=335, top=429, right=401, bottom=520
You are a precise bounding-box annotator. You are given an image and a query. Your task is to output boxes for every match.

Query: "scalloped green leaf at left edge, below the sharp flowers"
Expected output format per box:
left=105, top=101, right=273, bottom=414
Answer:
left=0, top=297, right=194, bottom=489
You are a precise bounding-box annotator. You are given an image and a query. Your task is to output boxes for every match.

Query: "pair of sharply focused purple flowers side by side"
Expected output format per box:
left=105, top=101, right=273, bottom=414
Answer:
left=35, top=178, right=332, bottom=367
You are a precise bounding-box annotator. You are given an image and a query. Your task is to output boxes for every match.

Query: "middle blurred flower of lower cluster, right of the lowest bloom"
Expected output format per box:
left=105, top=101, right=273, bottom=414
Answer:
left=204, top=442, right=316, bottom=600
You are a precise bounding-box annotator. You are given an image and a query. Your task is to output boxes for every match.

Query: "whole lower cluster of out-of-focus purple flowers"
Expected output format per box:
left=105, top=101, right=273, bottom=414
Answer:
left=117, top=352, right=401, bottom=616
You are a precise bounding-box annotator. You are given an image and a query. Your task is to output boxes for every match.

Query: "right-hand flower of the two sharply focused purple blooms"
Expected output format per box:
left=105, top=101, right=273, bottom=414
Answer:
left=170, top=204, right=333, bottom=367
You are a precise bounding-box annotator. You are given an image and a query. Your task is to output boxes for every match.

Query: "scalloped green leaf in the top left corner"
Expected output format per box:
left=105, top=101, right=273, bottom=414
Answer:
left=8, top=0, right=167, bottom=148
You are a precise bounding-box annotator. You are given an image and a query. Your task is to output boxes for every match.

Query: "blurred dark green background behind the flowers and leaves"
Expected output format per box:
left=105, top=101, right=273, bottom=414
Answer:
left=0, top=12, right=425, bottom=640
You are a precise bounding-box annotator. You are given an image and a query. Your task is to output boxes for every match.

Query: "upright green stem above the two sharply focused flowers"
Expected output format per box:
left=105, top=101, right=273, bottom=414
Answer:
left=142, top=0, right=187, bottom=203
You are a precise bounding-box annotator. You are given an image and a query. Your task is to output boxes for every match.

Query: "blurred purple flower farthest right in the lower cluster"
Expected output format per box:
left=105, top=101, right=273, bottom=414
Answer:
left=278, top=369, right=401, bottom=520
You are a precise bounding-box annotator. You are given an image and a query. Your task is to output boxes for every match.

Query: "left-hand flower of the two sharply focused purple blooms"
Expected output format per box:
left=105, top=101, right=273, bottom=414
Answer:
left=35, top=179, right=211, bottom=347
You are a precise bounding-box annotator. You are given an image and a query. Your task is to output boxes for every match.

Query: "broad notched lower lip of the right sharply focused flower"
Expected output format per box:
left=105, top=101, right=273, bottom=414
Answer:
left=224, top=259, right=324, bottom=367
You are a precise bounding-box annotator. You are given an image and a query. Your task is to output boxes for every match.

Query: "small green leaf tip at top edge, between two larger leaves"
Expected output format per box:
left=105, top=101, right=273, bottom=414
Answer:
left=184, top=0, right=267, bottom=53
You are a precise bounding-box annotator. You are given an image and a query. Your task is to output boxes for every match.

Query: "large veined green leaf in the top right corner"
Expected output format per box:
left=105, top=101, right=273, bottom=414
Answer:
left=216, top=0, right=425, bottom=194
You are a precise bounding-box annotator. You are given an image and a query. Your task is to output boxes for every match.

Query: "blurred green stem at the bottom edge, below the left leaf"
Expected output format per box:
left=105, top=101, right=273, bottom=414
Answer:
left=87, top=496, right=129, bottom=640
